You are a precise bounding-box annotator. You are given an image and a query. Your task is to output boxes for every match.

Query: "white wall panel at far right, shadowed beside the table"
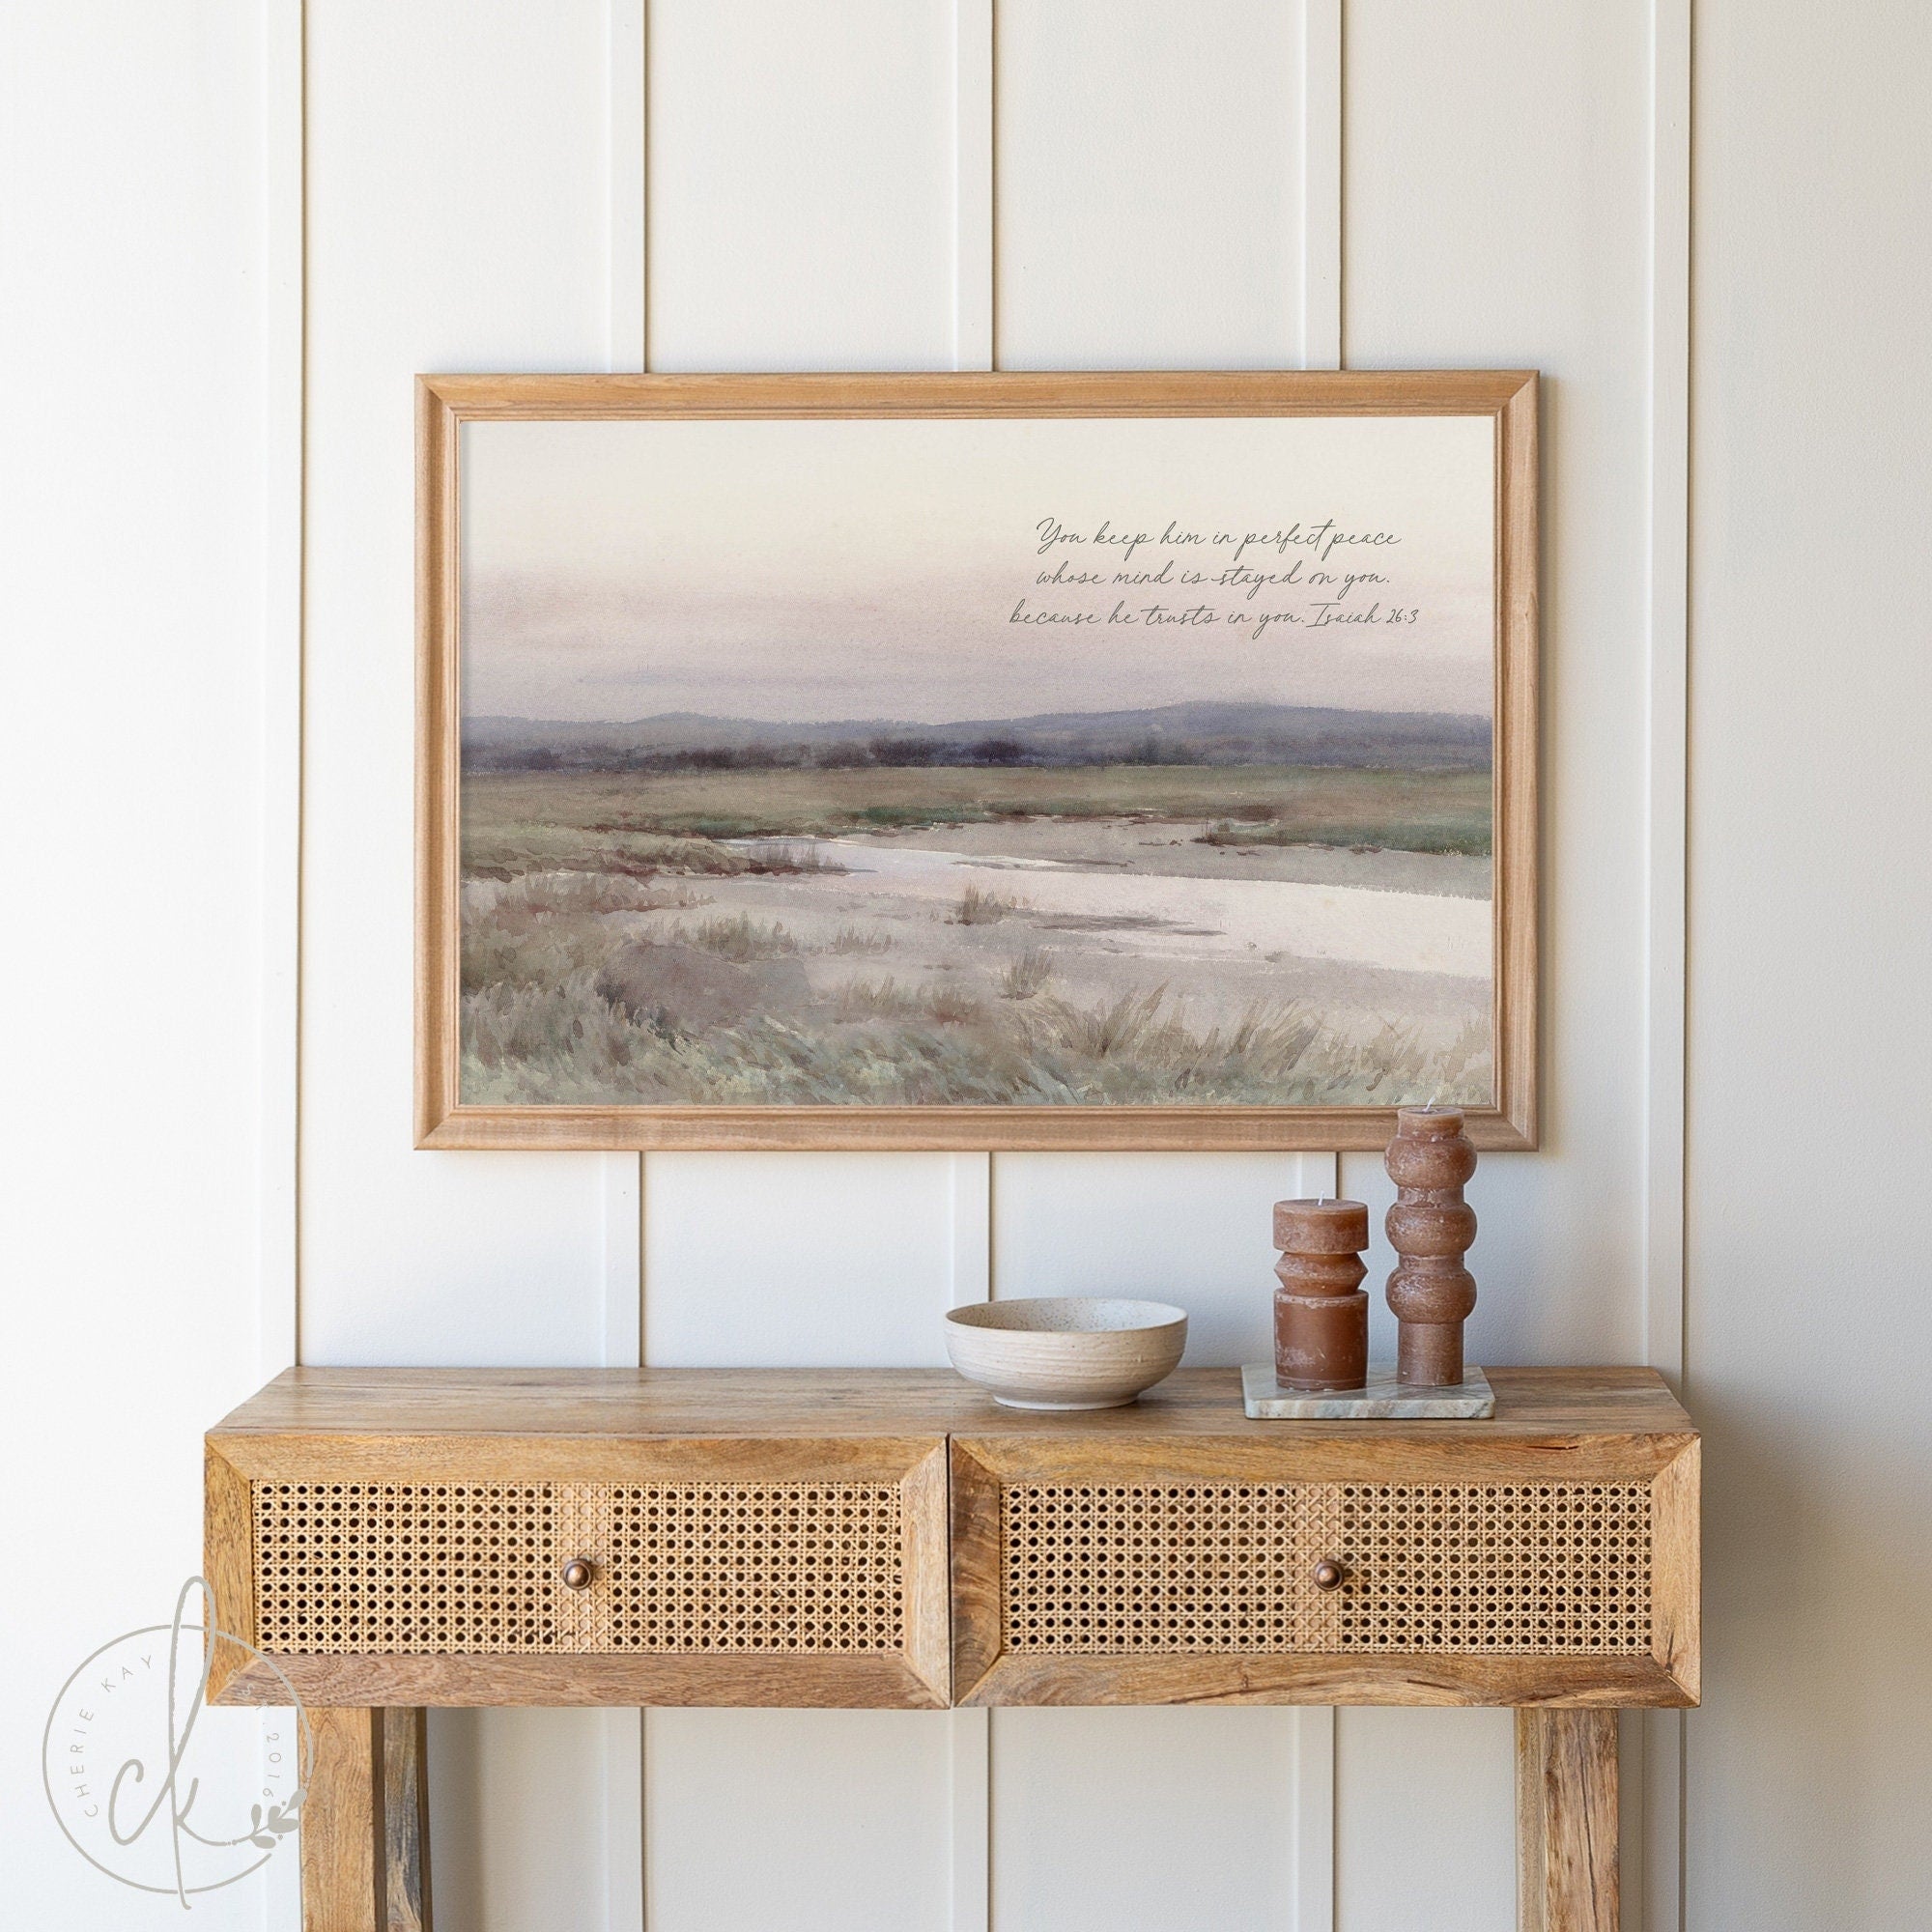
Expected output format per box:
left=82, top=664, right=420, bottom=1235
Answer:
left=1685, top=0, right=1932, bottom=1932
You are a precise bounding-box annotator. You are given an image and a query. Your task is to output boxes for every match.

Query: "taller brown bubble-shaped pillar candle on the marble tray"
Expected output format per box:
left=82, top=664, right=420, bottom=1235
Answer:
left=1385, top=1107, right=1476, bottom=1389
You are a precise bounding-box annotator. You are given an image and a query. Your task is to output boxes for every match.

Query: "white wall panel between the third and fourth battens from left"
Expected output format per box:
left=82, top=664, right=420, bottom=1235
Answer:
left=991, top=0, right=1302, bottom=1928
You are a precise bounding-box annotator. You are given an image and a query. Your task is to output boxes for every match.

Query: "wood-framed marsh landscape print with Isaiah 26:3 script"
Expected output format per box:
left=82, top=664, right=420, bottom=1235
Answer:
left=417, top=371, right=1536, bottom=1148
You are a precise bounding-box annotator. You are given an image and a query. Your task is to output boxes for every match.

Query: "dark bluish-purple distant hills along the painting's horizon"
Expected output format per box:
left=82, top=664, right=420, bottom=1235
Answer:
left=464, top=703, right=1490, bottom=771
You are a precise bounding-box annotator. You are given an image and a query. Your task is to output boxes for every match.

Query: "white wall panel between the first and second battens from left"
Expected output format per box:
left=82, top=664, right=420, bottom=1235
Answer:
left=301, top=0, right=611, bottom=1932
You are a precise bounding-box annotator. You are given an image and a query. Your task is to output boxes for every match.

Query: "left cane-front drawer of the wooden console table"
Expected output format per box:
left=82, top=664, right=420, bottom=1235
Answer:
left=211, top=1441, right=947, bottom=1704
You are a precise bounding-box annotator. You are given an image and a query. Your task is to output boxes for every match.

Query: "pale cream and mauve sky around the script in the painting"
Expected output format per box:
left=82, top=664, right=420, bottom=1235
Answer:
left=462, top=417, right=1493, bottom=724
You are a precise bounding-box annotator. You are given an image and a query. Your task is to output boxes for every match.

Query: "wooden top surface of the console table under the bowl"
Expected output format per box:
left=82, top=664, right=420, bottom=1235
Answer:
left=211, top=1366, right=1694, bottom=1443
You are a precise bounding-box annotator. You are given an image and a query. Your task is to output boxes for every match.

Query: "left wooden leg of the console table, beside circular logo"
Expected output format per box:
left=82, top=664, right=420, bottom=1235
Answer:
left=301, top=1710, right=431, bottom=1932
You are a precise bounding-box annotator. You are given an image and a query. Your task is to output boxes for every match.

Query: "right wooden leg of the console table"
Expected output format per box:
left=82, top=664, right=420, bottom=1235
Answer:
left=1517, top=1710, right=1617, bottom=1932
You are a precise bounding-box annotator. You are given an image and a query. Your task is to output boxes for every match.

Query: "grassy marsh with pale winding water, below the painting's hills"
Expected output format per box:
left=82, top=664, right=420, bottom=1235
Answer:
left=462, top=757, right=1492, bottom=1105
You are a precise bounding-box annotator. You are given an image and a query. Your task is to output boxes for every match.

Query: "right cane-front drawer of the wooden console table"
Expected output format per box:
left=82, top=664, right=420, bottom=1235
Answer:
left=952, top=1443, right=1696, bottom=1704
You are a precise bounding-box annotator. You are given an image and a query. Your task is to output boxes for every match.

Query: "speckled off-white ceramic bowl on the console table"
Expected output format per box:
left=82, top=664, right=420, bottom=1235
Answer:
left=947, top=1294, right=1188, bottom=1408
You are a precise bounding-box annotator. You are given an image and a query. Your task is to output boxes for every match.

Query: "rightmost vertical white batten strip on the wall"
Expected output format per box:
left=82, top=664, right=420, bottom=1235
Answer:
left=1625, top=0, right=1692, bottom=1932
